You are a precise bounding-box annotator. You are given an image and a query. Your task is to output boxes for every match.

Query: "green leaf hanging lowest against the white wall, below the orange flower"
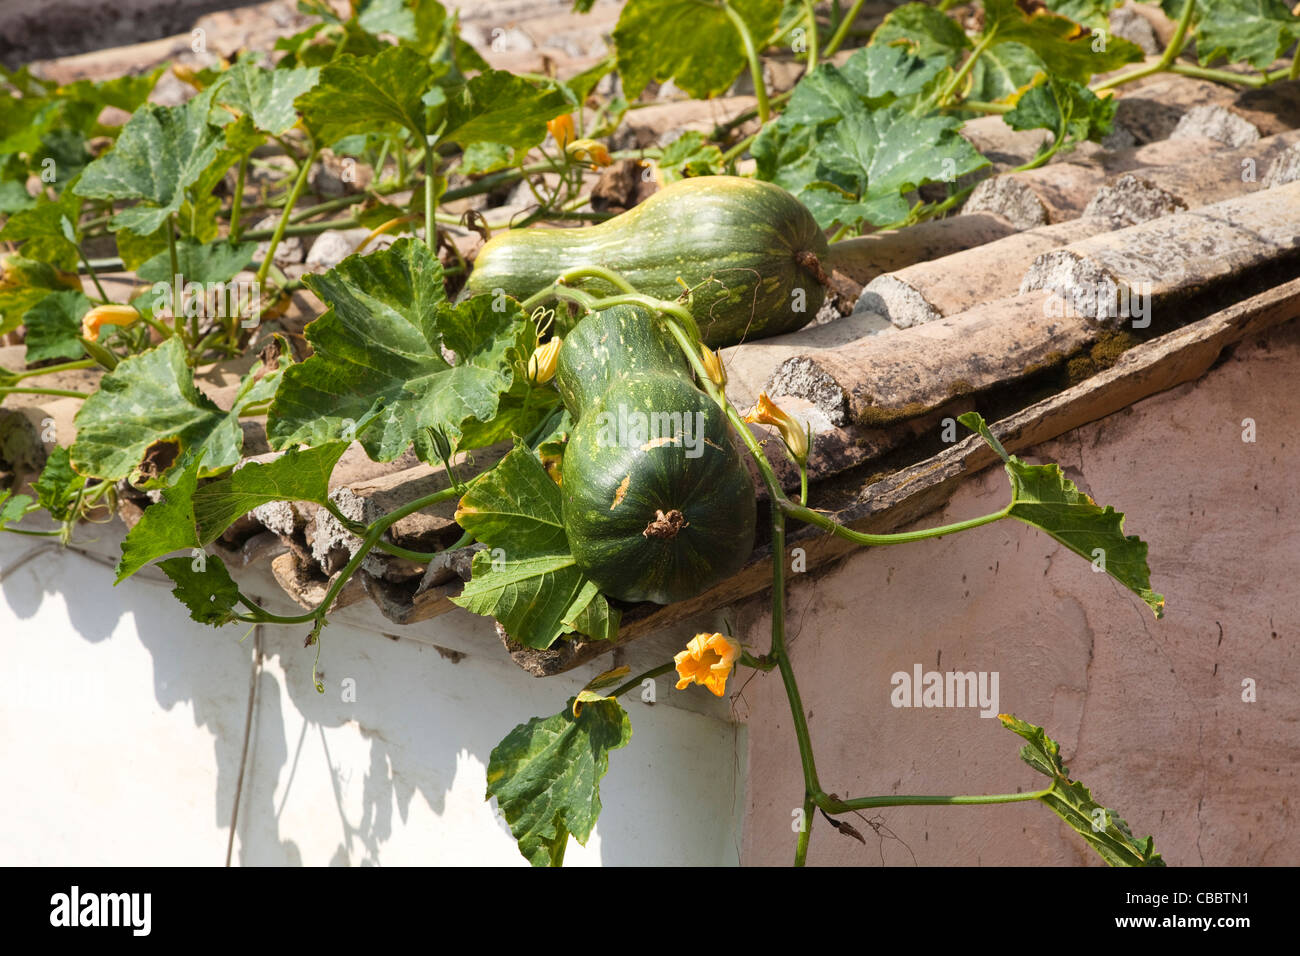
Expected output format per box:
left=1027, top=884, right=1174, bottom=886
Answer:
left=488, top=698, right=632, bottom=866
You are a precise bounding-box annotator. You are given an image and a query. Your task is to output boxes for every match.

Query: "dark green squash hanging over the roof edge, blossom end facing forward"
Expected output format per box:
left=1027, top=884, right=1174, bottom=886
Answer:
left=555, top=306, right=757, bottom=604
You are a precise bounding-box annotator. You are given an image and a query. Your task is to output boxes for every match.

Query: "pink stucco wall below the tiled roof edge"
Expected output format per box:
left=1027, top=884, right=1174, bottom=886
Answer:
left=736, top=323, right=1300, bottom=865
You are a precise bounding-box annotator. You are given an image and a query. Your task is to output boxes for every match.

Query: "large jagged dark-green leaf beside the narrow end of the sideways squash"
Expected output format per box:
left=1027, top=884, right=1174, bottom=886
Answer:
left=267, top=238, right=536, bottom=462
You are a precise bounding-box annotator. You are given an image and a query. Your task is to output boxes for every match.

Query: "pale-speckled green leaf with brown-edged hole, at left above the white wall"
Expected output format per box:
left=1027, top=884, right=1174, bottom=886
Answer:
left=72, top=338, right=289, bottom=483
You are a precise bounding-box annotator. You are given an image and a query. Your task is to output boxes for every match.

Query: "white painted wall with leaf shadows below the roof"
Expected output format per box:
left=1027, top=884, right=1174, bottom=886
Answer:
left=0, top=527, right=745, bottom=865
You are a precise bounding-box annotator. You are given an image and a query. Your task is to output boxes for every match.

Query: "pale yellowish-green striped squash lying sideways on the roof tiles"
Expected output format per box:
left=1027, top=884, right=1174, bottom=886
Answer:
left=467, top=176, right=827, bottom=349
